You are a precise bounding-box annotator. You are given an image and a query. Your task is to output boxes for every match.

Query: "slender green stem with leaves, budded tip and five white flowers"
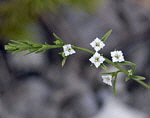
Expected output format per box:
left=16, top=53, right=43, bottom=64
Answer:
left=5, top=30, right=150, bottom=96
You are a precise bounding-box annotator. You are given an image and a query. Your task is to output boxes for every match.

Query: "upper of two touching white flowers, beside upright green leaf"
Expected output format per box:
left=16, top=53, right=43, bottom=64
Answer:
left=90, top=38, right=105, bottom=52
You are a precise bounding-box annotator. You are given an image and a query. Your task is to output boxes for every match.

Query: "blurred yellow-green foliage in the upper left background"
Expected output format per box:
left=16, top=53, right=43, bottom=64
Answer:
left=0, top=0, right=100, bottom=40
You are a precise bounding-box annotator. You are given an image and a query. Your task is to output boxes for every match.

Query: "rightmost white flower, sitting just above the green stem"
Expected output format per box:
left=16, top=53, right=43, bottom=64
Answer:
left=111, top=51, right=124, bottom=62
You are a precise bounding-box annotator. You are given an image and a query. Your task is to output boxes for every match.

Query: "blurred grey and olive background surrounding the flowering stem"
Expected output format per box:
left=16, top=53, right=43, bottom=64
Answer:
left=0, top=0, right=150, bottom=118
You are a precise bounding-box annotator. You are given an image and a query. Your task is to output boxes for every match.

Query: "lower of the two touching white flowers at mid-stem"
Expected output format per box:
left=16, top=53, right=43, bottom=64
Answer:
left=89, top=52, right=105, bottom=68
